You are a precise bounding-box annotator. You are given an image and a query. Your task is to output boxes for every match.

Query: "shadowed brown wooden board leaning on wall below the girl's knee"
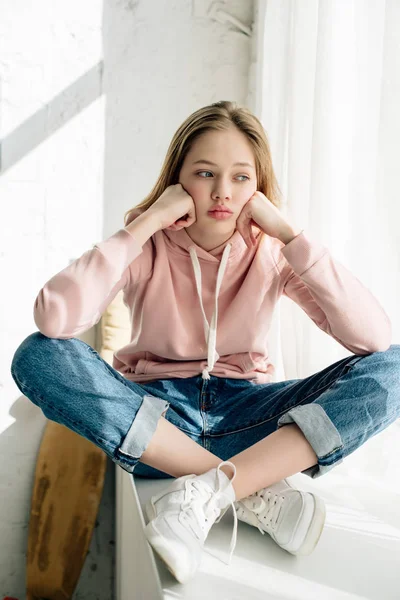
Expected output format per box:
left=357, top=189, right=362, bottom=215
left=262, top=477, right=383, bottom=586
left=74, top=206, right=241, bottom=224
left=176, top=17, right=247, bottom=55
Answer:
left=27, top=421, right=107, bottom=600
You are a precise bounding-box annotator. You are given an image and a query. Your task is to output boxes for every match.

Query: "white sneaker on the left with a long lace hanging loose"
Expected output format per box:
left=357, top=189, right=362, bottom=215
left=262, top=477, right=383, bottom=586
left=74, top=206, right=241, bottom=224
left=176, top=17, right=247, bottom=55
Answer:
left=144, top=461, right=237, bottom=583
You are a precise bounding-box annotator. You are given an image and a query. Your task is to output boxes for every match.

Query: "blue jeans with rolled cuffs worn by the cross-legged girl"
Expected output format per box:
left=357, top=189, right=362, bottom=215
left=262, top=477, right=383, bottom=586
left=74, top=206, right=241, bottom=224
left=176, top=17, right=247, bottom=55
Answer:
left=11, top=332, right=400, bottom=478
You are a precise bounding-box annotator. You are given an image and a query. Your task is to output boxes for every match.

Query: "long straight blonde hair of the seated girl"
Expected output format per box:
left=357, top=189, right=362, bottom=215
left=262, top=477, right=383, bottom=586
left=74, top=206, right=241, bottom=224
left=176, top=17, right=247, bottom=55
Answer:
left=124, top=100, right=281, bottom=226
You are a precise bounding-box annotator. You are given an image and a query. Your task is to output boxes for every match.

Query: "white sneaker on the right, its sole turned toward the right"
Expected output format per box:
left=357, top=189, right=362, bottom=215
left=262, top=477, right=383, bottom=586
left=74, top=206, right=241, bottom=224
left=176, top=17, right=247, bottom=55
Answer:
left=235, top=479, right=326, bottom=555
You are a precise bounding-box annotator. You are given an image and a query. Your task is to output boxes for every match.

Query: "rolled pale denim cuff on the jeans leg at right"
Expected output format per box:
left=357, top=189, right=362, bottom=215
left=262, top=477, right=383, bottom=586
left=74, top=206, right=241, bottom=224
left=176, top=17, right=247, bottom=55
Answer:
left=277, top=402, right=343, bottom=479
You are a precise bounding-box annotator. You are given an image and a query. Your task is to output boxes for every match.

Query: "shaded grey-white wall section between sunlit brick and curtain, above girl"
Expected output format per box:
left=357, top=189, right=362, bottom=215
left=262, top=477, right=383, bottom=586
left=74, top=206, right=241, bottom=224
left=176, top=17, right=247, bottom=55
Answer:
left=103, top=0, right=252, bottom=235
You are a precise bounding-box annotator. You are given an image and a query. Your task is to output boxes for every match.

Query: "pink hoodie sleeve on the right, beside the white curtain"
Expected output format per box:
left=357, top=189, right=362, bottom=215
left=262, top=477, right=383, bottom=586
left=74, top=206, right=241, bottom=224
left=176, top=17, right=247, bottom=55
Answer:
left=278, top=230, right=392, bottom=355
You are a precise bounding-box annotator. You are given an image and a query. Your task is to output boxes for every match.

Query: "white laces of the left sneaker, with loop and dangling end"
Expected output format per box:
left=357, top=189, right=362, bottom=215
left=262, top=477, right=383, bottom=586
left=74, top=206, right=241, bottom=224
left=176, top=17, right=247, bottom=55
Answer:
left=181, top=461, right=237, bottom=565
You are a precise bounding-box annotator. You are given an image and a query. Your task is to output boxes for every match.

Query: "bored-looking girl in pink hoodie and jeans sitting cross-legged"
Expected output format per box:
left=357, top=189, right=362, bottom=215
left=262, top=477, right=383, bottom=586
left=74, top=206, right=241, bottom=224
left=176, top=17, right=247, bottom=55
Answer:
left=12, top=101, right=400, bottom=582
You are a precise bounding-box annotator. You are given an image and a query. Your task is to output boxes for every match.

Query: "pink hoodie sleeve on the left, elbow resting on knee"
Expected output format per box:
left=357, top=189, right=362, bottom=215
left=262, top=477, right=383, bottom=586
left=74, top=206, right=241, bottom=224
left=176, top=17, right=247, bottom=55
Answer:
left=33, top=229, right=143, bottom=339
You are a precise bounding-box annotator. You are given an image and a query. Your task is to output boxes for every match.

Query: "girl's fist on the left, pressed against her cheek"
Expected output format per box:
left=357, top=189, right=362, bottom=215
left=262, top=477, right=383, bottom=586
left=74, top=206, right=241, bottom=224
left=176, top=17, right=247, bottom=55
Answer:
left=146, top=183, right=196, bottom=231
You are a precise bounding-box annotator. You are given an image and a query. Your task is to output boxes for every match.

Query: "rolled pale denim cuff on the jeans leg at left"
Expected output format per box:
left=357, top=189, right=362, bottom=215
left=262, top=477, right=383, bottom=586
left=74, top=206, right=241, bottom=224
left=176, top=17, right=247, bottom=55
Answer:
left=114, top=395, right=170, bottom=473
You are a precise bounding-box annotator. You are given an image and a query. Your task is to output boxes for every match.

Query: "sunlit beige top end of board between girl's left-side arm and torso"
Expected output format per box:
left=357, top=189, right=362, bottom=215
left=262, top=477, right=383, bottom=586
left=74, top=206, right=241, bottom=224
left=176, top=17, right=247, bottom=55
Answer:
left=96, top=290, right=130, bottom=365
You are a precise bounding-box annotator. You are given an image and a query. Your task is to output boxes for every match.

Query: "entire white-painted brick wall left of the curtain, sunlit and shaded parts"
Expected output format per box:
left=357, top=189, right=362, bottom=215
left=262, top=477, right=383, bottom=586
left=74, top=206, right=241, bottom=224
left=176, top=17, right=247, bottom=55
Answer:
left=0, top=0, right=254, bottom=600
